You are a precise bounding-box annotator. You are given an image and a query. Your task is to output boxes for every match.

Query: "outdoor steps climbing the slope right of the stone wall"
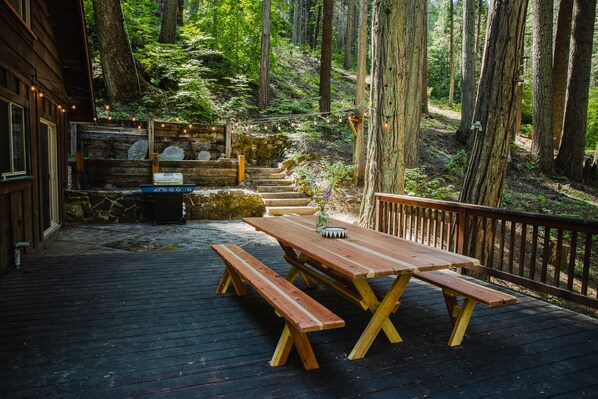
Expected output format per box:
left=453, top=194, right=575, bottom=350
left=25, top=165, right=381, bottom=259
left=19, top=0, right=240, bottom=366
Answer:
left=245, top=167, right=317, bottom=216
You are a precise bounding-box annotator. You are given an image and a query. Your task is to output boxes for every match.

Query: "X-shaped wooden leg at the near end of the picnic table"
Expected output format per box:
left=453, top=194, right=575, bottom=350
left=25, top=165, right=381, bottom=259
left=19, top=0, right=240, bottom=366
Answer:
left=349, top=274, right=411, bottom=360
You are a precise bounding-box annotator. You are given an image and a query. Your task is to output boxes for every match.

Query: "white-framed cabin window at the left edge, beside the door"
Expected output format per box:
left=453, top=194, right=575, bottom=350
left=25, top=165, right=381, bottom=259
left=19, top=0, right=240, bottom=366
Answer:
left=0, top=99, right=27, bottom=179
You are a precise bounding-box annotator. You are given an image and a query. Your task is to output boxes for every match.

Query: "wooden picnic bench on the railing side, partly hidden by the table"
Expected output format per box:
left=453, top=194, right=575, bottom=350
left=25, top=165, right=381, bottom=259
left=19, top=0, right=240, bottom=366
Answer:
left=414, top=270, right=517, bottom=346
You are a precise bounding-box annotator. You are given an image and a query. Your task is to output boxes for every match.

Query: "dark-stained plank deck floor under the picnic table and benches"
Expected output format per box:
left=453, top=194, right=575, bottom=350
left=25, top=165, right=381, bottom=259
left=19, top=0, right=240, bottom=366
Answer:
left=0, top=247, right=598, bottom=398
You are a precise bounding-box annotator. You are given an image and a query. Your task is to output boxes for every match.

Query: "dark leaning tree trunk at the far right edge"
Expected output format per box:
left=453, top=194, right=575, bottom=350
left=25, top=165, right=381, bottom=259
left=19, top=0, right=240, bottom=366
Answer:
left=556, top=0, right=596, bottom=180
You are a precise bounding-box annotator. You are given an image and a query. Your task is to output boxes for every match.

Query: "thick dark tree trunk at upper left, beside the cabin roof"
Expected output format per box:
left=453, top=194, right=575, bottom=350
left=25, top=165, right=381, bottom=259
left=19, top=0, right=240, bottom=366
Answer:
left=93, top=0, right=141, bottom=101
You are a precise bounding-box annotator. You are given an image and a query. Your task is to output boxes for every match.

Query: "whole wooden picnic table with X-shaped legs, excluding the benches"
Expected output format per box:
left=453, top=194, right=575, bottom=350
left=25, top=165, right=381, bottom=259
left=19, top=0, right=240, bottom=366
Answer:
left=243, top=216, right=479, bottom=359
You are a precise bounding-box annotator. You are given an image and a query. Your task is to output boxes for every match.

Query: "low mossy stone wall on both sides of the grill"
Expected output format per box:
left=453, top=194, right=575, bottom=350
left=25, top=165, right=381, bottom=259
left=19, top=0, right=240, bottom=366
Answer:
left=65, top=189, right=265, bottom=223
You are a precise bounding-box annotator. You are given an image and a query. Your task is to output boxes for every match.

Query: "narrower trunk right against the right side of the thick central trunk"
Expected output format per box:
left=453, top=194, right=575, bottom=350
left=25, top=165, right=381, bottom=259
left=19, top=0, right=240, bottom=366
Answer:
left=403, top=0, right=426, bottom=169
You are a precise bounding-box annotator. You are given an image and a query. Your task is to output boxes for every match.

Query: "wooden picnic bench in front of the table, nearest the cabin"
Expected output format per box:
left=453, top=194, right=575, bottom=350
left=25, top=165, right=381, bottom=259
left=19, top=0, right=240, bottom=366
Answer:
left=211, top=244, right=345, bottom=370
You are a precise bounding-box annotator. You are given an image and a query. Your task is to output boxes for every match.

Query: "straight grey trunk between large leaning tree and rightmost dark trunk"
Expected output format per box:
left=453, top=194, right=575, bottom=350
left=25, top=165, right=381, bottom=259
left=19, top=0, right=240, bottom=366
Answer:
left=532, top=0, right=554, bottom=173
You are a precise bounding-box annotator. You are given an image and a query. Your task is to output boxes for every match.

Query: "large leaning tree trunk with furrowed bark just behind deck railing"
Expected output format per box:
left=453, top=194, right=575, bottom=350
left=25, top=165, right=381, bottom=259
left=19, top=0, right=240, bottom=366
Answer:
left=460, top=0, right=527, bottom=207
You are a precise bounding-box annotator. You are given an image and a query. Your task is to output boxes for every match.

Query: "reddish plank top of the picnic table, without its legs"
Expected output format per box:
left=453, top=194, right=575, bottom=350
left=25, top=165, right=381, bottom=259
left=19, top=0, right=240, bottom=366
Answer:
left=243, top=216, right=479, bottom=279
